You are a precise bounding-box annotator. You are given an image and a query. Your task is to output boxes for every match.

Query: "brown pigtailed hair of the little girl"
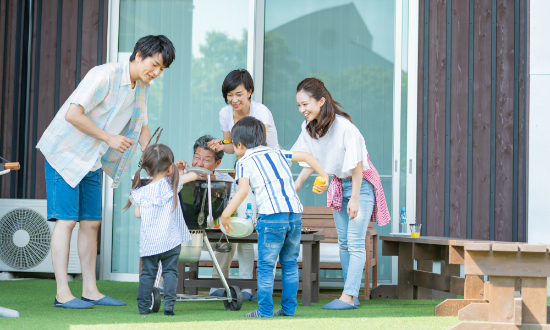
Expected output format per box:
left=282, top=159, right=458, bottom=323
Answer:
left=124, top=144, right=179, bottom=210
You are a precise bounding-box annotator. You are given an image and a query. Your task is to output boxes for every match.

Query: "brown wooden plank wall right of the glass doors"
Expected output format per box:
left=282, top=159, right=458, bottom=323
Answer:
left=416, top=0, right=529, bottom=241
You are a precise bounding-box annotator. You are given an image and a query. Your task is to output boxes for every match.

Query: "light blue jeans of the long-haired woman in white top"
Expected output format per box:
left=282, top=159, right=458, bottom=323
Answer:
left=333, top=178, right=374, bottom=297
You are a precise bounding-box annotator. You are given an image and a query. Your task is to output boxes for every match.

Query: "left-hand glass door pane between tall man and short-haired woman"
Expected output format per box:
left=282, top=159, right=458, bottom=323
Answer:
left=111, top=0, right=248, bottom=274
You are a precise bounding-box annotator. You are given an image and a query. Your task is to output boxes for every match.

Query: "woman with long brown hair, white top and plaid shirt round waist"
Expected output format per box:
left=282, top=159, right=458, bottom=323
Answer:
left=292, top=78, right=390, bottom=310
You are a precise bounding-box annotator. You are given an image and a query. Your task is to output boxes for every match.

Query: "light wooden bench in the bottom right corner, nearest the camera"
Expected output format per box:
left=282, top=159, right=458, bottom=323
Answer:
left=448, top=242, right=550, bottom=329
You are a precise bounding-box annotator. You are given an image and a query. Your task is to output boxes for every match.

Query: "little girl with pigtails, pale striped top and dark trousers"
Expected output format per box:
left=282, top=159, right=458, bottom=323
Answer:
left=124, top=144, right=197, bottom=315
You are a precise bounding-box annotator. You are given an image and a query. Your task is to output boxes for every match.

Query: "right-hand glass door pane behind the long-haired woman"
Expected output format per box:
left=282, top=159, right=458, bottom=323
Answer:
left=263, top=0, right=399, bottom=280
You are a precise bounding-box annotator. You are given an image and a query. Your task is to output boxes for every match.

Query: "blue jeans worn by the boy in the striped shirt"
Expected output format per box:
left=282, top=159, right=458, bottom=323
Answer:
left=256, top=212, right=302, bottom=317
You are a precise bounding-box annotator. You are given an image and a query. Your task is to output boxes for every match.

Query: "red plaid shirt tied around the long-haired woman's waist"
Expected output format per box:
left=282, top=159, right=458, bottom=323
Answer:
left=327, top=158, right=390, bottom=226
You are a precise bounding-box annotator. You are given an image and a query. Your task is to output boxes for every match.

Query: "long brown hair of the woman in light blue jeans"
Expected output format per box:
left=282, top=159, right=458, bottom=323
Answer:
left=296, top=78, right=351, bottom=139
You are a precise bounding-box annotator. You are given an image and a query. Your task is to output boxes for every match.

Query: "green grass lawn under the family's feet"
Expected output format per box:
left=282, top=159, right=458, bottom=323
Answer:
left=0, top=280, right=548, bottom=330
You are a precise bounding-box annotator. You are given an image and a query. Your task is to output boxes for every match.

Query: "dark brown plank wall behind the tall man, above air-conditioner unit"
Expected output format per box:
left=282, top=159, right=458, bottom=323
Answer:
left=0, top=0, right=108, bottom=199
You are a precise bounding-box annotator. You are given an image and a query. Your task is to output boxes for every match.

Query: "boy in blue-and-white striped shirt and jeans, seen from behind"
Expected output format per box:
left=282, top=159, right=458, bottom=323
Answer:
left=221, top=117, right=328, bottom=317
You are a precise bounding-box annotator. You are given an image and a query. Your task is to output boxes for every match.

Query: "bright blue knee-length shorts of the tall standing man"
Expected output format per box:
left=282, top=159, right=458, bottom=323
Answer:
left=44, top=160, right=103, bottom=221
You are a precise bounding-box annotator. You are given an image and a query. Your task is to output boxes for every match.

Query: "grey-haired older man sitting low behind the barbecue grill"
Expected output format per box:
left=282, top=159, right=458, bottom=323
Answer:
left=184, top=135, right=256, bottom=300
